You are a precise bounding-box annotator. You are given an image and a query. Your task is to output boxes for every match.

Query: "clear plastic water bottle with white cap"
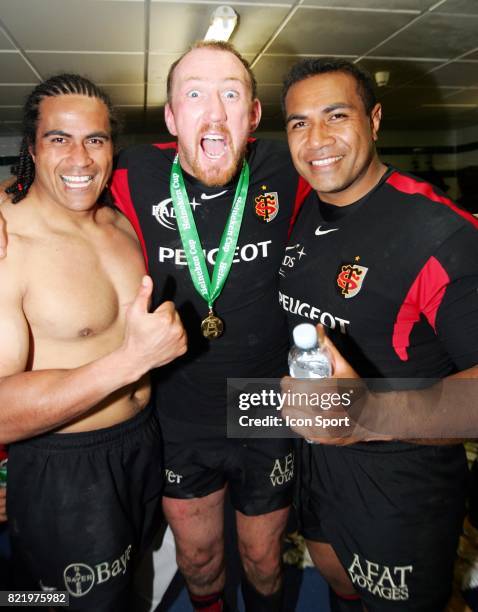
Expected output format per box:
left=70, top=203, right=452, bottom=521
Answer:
left=289, top=323, right=332, bottom=378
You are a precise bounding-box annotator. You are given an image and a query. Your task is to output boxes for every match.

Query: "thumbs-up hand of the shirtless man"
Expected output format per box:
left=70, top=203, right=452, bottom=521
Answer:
left=123, top=276, right=187, bottom=378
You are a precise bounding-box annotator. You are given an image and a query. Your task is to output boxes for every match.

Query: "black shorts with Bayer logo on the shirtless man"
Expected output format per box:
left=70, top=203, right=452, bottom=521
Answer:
left=7, top=407, right=163, bottom=612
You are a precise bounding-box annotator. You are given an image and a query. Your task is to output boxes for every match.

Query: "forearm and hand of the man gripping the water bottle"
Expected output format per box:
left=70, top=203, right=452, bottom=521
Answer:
left=282, top=330, right=478, bottom=446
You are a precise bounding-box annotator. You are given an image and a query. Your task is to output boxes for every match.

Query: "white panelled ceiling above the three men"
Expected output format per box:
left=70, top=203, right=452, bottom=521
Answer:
left=0, top=0, right=478, bottom=133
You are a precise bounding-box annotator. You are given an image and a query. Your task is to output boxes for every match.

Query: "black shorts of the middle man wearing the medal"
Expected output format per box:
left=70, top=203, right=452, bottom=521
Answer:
left=160, top=416, right=295, bottom=516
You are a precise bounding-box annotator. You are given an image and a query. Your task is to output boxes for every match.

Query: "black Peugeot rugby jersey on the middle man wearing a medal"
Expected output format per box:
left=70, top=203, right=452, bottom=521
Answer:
left=112, top=140, right=309, bottom=424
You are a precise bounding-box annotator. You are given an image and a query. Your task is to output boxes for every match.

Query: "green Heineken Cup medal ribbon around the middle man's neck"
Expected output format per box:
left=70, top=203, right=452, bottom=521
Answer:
left=169, top=154, right=249, bottom=334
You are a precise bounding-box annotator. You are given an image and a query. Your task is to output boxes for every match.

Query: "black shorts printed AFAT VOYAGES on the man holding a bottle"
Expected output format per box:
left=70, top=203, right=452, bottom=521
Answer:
left=298, top=441, right=467, bottom=612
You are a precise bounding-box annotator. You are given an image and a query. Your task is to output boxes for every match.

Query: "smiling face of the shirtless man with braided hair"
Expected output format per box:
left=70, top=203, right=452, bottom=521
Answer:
left=30, top=95, right=113, bottom=211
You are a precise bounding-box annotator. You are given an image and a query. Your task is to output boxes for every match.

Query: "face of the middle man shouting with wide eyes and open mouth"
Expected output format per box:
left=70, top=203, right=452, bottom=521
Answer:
left=165, top=48, right=261, bottom=186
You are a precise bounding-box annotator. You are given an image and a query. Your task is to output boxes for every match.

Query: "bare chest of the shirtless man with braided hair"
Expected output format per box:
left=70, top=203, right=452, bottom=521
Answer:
left=23, top=232, right=144, bottom=342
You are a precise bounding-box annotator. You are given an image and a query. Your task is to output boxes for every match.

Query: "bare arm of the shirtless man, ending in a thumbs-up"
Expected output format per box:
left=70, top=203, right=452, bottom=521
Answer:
left=0, top=274, right=186, bottom=443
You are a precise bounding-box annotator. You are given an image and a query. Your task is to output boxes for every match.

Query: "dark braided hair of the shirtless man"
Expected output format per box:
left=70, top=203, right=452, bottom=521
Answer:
left=5, top=74, right=119, bottom=204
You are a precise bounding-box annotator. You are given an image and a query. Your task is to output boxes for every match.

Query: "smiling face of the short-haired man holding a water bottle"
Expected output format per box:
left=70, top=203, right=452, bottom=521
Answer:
left=285, top=72, right=385, bottom=206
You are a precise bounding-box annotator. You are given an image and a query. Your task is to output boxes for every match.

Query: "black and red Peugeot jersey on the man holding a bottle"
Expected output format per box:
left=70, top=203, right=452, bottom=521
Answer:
left=279, top=169, right=478, bottom=378
